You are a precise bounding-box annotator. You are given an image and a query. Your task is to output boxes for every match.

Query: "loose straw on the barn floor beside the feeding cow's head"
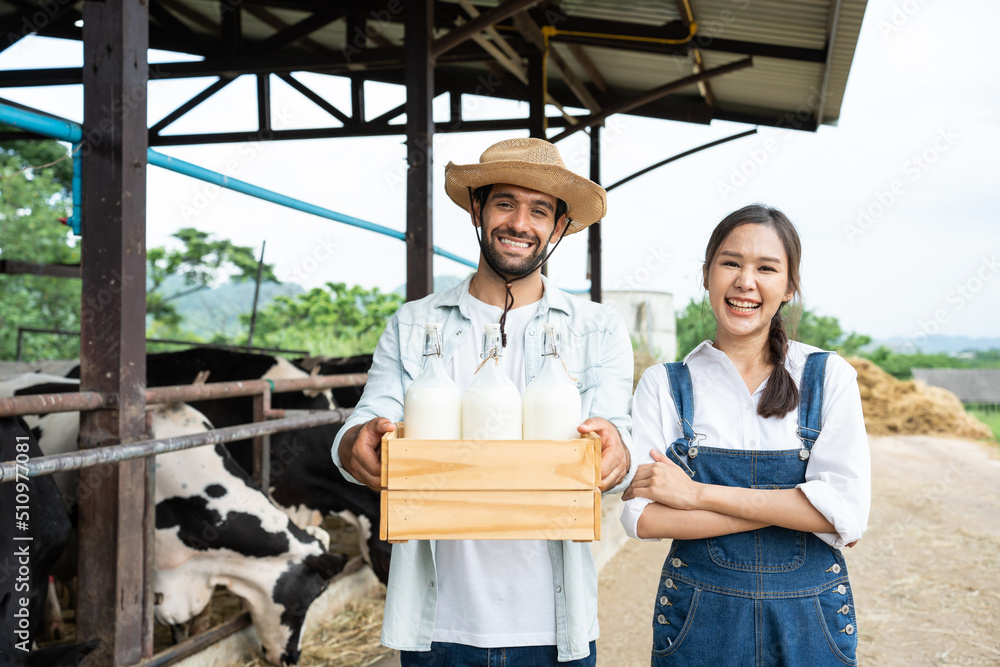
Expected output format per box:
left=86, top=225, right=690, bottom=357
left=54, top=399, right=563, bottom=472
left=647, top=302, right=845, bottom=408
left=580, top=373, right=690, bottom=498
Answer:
left=232, top=598, right=393, bottom=667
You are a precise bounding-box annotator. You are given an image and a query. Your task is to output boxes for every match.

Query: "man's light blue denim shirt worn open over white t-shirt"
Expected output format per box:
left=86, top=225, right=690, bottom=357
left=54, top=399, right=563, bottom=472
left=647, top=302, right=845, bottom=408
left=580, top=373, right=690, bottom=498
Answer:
left=333, top=276, right=639, bottom=662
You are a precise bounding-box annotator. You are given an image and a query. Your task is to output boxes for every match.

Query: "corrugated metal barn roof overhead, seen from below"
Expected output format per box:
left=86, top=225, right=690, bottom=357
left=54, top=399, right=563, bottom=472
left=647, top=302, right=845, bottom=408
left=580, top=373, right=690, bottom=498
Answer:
left=0, top=0, right=867, bottom=130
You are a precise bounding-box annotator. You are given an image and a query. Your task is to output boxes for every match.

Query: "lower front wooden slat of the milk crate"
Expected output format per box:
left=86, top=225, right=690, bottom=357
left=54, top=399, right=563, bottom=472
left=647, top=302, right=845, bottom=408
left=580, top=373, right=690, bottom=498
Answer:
left=382, top=489, right=600, bottom=541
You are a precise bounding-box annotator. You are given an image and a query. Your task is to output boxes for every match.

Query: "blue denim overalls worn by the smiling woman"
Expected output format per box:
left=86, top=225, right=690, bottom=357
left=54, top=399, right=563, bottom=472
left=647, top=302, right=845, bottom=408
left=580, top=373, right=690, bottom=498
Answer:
left=651, top=352, right=858, bottom=667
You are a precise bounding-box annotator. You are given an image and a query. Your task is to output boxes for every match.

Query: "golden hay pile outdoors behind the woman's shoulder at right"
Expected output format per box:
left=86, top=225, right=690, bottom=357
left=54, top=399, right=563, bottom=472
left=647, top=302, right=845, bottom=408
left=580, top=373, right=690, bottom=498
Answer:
left=847, top=359, right=993, bottom=440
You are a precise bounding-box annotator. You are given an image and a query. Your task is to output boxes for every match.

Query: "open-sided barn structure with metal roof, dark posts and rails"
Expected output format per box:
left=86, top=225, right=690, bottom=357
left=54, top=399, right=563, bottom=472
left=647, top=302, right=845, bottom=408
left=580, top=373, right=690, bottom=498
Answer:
left=0, top=0, right=865, bottom=665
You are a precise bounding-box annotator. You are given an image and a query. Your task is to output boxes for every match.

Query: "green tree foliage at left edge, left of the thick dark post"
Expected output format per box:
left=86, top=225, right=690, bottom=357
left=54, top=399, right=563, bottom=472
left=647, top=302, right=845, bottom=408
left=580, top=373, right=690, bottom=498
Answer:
left=0, top=141, right=80, bottom=360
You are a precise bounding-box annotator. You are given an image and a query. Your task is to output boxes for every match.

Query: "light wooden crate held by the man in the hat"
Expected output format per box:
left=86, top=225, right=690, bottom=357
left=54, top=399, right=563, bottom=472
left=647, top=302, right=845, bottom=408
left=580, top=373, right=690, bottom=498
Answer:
left=379, top=424, right=601, bottom=542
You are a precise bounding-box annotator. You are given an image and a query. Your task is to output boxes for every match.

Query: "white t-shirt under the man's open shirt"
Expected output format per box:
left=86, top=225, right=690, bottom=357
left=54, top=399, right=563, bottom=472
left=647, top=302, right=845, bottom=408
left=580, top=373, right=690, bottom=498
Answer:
left=433, top=295, right=556, bottom=648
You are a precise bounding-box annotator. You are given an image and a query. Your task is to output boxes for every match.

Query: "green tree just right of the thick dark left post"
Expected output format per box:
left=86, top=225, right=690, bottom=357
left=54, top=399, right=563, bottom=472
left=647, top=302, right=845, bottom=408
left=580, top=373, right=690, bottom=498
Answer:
left=146, top=227, right=279, bottom=337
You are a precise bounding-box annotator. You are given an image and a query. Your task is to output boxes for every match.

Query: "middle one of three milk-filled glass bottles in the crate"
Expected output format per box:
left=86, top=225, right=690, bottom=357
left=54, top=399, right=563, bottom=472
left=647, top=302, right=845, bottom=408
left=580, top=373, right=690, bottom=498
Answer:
left=462, top=324, right=521, bottom=440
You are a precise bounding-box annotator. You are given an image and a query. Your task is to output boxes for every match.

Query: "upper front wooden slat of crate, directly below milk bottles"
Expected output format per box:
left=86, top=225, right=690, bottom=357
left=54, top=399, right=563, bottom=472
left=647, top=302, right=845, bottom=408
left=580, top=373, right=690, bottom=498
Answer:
left=383, top=439, right=600, bottom=491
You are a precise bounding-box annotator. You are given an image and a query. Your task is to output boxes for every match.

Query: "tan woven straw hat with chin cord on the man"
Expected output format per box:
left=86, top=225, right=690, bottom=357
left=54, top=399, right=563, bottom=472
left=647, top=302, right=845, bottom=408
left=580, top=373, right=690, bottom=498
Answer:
left=444, top=139, right=608, bottom=234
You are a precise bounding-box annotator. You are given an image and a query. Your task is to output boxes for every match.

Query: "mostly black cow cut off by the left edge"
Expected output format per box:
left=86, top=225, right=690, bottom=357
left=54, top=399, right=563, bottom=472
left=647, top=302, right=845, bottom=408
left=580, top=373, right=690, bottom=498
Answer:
left=0, top=417, right=100, bottom=667
